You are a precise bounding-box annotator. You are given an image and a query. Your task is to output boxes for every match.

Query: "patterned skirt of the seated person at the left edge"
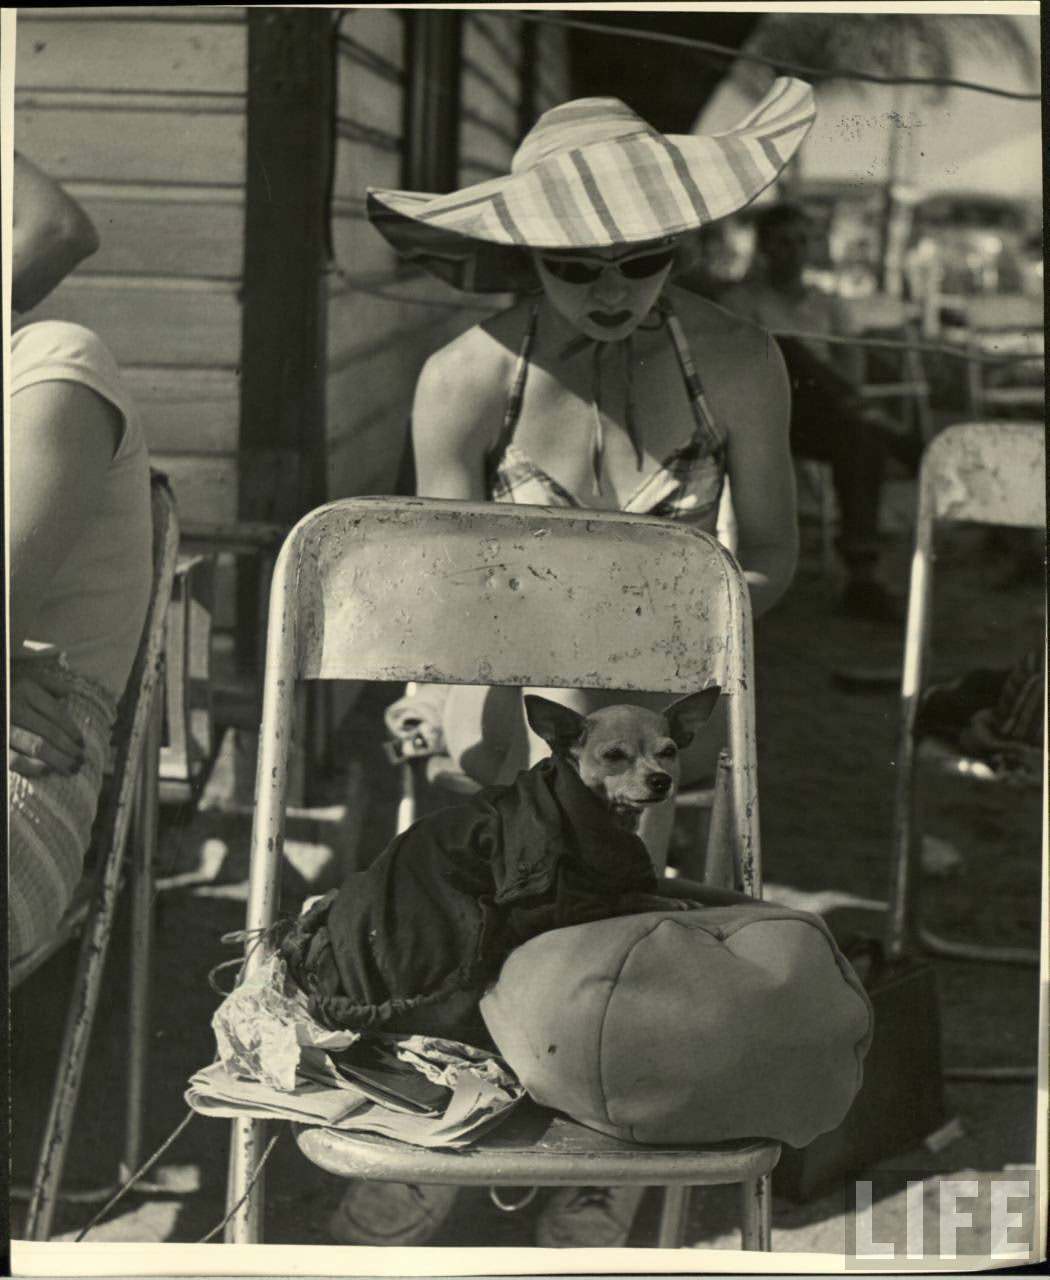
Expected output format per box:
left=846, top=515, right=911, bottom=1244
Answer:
left=8, top=658, right=117, bottom=960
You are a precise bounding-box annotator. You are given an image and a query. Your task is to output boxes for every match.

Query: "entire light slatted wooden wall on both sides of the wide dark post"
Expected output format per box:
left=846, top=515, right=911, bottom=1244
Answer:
left=15, top=6, right=567, bottom=521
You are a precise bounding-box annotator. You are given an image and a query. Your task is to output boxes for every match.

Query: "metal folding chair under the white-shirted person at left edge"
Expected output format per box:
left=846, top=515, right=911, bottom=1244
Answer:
left=10, top=475, right=179, bottom=1240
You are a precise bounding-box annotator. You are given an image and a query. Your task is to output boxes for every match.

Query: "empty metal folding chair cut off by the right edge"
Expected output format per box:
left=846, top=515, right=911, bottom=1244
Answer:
left=887, top=422, right=1046, bottom=1079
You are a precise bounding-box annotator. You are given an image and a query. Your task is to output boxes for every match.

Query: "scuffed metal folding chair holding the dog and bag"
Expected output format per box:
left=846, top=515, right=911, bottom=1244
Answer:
left=227, top=498, right=780, bottom=1249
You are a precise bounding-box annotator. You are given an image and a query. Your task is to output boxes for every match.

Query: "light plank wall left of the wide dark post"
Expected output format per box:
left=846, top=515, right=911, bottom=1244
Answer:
left=15, top=6, right=247, bottom=521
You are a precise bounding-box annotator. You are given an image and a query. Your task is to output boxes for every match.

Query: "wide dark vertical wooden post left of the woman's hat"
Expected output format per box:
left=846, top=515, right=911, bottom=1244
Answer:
left=237, top=8, right=334, bottom=668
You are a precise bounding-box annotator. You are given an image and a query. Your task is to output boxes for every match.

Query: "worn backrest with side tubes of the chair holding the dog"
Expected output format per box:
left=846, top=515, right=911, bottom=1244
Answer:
left=248, top=498, right=758, bottom=928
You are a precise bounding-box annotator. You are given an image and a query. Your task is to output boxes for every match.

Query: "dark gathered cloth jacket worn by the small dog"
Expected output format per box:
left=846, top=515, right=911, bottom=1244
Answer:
left=280, top=758, right=657, bottom=1041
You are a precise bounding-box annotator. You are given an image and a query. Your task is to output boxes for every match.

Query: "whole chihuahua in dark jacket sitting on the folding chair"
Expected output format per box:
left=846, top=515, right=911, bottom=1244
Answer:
left=282, top=689, right=718, bottom=1041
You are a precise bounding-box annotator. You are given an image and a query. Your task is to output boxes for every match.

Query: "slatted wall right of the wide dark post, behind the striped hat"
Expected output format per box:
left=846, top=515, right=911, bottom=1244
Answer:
left=328, top=9, right=567, bottom=498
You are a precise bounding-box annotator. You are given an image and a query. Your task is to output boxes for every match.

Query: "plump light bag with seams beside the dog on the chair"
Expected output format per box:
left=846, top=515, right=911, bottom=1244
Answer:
left=481, top=902, right=872, bottom=1147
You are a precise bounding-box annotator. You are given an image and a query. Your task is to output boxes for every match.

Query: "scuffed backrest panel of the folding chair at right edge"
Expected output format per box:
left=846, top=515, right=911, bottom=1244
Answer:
left=918, top=422, right=1046, bottom=529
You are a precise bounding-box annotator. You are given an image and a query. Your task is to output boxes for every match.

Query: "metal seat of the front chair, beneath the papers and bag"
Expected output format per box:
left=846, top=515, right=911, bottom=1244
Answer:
left=295, top=1102, right=780, bottom=1187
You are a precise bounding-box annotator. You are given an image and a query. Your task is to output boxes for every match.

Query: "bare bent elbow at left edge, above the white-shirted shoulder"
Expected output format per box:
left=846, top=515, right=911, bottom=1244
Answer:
left=12, top=152, right=99, bottom=312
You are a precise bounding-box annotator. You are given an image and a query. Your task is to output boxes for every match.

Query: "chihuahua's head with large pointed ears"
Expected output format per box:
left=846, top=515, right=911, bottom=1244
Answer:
left=525, top=686, right=721, bottom=831
